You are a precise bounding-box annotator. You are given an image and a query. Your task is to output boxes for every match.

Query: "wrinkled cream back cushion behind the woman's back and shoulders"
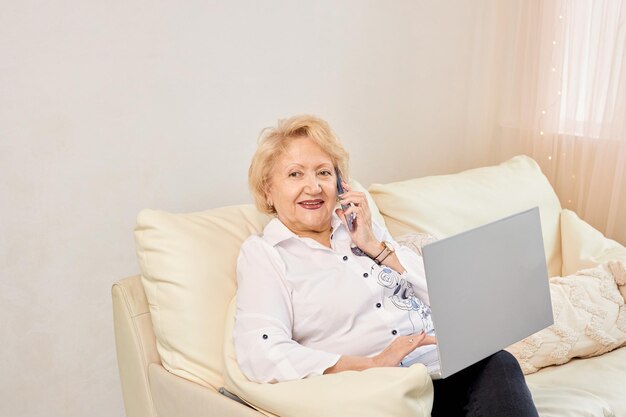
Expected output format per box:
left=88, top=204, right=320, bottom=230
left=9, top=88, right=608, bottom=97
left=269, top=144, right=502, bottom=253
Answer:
left=135, top=180, right=382, bottom=389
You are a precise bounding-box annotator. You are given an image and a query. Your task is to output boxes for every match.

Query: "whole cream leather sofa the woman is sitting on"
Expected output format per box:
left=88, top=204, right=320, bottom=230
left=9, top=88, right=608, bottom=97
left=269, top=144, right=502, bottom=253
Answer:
left=112, top=156, right=626, bottom=417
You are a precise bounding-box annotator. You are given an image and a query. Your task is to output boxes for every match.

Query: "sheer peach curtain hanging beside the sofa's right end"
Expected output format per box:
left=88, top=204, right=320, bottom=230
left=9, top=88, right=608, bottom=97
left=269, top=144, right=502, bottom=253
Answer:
left=493, top=0, right=626, bottom=244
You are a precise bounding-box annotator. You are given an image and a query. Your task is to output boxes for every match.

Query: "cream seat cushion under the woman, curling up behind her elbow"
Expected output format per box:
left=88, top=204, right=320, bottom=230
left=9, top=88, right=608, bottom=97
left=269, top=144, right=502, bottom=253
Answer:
left=224, top=299, right=433, bottom=417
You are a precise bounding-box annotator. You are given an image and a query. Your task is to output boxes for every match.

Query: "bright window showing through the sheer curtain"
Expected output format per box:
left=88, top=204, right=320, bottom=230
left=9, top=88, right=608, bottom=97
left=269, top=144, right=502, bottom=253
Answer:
left=553, top=0, right=626, bottom=138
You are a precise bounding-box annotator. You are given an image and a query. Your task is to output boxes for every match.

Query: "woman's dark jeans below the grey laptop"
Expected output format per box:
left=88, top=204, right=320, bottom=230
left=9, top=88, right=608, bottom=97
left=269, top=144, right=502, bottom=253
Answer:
left=432, top=351, right=539, bottom=417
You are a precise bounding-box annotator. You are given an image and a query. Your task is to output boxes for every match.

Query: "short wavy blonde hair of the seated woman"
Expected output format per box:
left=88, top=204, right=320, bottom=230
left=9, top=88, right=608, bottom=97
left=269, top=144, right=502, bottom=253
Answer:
left=248, top=115, right=349, bottom=214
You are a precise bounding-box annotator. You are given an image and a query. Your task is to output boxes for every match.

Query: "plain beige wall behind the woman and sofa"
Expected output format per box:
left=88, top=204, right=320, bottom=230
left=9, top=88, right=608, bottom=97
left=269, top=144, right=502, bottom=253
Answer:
left=0, top=0, right=502, bottom=417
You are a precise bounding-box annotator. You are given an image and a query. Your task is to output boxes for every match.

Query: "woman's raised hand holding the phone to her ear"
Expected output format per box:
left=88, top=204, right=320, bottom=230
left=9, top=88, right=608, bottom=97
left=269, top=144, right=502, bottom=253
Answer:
left=335, top=181, right=382, bottom=252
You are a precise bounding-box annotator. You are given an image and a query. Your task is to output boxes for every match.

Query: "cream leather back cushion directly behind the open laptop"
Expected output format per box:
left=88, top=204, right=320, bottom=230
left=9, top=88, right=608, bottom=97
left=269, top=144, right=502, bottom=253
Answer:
left=369, top=155, right=561, bottom=276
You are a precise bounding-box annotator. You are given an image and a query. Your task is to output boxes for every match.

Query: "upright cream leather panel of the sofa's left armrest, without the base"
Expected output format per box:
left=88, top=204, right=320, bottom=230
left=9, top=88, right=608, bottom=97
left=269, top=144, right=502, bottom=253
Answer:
left=111, top=275, right=161, bottom=417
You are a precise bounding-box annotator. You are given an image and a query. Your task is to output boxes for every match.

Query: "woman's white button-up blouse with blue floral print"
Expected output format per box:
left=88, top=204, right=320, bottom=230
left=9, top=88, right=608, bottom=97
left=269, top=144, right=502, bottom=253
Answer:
left=233, top=214, right=436, bottom=382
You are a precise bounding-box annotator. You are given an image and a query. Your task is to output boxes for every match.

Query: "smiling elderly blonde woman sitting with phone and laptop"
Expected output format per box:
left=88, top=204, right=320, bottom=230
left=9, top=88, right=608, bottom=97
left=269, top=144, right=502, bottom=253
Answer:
left=233, top=116, right=537, bottom=416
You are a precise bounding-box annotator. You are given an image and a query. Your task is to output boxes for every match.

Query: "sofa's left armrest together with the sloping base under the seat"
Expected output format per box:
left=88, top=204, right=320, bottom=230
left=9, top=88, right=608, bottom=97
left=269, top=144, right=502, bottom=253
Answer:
left=111, top=275, right=263, bottom=417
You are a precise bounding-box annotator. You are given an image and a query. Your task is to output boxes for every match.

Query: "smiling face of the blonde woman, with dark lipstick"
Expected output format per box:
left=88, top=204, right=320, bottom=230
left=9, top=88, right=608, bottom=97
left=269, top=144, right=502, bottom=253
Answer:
left=267, top=138, right=337, bottom=237
